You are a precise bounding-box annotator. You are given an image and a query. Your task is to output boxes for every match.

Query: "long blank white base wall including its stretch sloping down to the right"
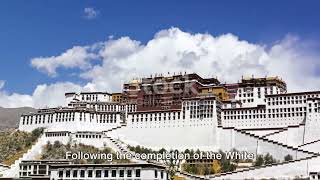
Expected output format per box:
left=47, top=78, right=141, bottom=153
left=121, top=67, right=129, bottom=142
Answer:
left=107, top=124, right=308, bottom=161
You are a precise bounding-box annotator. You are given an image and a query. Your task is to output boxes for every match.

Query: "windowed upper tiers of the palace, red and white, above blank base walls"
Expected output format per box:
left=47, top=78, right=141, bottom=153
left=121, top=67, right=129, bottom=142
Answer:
left=19, top=74, right=319, bottom=131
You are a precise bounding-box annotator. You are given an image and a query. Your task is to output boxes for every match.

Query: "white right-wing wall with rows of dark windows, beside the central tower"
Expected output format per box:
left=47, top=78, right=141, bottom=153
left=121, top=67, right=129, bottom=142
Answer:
left=222, top=92, right=320, bottom=129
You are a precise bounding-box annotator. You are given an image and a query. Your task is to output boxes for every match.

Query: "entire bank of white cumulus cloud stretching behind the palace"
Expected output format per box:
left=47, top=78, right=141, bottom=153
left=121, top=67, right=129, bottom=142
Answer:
left=0, top=28, right=320, bottom=107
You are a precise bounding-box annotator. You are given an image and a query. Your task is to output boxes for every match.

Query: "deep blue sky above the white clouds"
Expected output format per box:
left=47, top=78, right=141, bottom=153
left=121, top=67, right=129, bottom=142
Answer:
left=0, top=0, right=320, bottom=107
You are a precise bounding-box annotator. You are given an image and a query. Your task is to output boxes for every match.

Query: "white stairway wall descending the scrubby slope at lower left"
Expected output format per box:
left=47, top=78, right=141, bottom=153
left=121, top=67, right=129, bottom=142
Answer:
left=3, top=133, right=46, bottom=178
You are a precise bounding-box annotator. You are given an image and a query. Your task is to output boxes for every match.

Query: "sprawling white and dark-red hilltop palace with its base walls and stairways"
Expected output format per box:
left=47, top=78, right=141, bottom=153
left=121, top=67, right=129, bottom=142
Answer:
left=3, top=73, right=320, bottom=179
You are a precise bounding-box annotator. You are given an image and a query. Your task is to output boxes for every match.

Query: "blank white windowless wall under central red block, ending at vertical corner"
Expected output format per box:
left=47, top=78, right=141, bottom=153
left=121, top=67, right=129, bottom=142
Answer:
left=107, top=122, right=218, bottom=150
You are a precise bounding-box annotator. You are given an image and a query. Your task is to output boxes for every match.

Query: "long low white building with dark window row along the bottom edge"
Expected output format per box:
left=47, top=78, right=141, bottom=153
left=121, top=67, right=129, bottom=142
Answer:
left=50, top=163, right=168, bottom=180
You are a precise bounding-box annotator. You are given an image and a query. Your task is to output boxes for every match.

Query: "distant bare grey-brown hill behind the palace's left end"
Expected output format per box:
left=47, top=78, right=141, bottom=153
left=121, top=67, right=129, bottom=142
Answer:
left=0, top=107, right=36, bottom=130
